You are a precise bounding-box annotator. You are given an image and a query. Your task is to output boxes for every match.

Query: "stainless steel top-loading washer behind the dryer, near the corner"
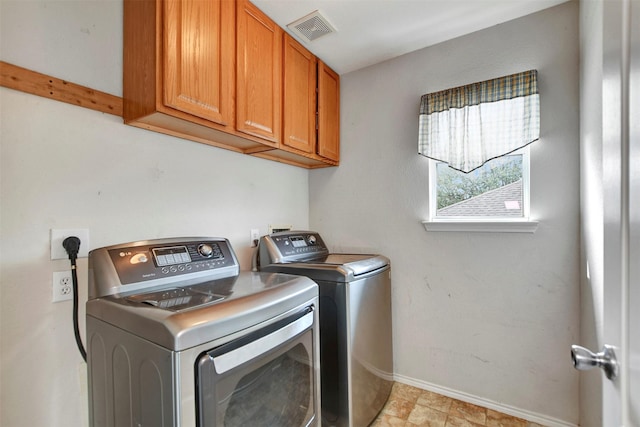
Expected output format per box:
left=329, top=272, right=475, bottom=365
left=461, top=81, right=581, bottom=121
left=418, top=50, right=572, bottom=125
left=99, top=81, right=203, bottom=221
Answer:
left=255, top=231, right=393, bottom=427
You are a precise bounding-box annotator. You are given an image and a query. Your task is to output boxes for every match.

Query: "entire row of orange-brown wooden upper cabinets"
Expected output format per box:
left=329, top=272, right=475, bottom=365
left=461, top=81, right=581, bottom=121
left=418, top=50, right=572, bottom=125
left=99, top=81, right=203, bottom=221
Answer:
left=122, top=0, right=340, bottom=168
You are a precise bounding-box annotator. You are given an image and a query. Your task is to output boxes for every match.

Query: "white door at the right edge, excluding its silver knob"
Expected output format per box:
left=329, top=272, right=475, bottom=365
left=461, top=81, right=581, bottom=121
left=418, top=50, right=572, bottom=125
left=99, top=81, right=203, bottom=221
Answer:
left=602, top=0, right=640, bottom=427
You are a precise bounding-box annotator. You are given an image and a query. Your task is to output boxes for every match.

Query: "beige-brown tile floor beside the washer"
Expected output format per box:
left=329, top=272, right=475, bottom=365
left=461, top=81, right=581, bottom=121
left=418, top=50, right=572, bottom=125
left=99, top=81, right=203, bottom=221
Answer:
left=371, top=383, right=544, bottom=427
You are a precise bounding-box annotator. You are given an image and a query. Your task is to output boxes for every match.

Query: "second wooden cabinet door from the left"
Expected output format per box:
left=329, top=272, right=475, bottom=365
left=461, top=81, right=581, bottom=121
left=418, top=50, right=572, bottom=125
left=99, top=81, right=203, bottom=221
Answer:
left=236, top=0, right=283, bottom=146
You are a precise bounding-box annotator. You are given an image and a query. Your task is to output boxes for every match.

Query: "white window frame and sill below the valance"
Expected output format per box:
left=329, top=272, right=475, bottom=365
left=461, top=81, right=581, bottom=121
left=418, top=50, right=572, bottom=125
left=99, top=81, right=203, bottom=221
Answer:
left=422, top=145, right=538, bottom=233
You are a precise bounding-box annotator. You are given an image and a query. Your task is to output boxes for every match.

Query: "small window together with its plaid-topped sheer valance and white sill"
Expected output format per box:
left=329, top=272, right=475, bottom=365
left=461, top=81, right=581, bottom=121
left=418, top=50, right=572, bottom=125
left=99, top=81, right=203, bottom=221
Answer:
left=418, top=70, right=540, bottom=232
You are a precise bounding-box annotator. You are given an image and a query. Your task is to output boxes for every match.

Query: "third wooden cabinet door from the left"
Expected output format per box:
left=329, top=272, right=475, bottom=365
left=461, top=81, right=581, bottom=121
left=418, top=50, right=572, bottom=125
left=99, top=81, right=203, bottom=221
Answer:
left=282, top=33, right=317, bottom=153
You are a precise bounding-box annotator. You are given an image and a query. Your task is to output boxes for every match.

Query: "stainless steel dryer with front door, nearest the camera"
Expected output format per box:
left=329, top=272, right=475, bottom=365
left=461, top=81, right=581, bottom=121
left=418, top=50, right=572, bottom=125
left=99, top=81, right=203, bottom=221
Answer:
left=86, top=237, right=320, bottom=427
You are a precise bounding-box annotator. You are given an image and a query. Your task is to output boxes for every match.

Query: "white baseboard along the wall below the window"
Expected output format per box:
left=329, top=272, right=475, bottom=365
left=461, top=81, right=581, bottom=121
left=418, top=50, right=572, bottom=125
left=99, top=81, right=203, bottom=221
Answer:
left=394, top=374, right=578, bottom=427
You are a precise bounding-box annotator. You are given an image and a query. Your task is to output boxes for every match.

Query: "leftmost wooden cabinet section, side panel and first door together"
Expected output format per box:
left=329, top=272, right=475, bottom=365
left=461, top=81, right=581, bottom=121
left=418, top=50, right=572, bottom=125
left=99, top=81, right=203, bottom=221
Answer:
left=123, top=0, right=236, bottom=130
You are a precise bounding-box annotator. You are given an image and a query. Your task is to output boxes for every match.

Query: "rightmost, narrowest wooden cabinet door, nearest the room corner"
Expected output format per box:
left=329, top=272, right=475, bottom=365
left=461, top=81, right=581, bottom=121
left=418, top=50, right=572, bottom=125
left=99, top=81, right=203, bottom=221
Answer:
left=318, top=61, right=340, bottom=162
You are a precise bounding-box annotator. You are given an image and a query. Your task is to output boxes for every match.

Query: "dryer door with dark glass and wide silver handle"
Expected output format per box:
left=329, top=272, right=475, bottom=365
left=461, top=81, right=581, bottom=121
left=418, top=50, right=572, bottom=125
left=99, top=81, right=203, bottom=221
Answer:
left=196, top=309, right=319, bottom=427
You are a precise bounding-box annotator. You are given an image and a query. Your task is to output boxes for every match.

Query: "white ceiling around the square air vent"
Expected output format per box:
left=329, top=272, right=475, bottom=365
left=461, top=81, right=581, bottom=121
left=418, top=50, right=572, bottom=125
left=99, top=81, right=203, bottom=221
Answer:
left=252, top=0, right=568, bottom=74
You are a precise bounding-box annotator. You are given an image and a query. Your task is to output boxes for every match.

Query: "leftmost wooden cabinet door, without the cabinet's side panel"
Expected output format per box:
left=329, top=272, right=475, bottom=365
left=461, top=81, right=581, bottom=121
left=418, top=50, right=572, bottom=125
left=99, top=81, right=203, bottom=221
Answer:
left=163, top=0, right=235, bottom=125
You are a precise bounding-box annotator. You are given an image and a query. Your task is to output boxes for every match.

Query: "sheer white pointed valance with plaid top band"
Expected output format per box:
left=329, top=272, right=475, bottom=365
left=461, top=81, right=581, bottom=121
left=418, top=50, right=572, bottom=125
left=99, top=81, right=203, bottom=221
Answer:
left=418, top=70, right=540, bottom=172
